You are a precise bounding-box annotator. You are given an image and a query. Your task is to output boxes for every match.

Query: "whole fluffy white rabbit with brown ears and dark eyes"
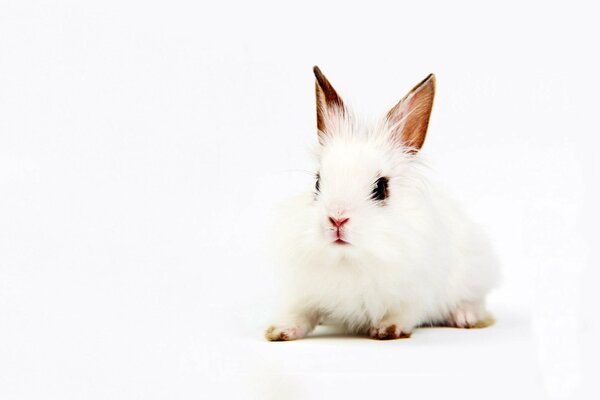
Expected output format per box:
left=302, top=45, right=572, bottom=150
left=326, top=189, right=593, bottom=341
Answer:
left=266, top=67, right=498, bottom=341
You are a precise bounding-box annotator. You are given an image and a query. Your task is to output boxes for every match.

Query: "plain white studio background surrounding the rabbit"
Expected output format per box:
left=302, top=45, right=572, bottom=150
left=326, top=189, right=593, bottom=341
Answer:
left=0, top=1, right=600, bottom=400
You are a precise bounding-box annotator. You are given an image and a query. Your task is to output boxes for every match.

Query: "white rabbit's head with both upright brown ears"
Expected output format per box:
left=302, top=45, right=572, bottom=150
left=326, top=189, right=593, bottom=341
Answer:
left=310, top=67, right=435, bottom=251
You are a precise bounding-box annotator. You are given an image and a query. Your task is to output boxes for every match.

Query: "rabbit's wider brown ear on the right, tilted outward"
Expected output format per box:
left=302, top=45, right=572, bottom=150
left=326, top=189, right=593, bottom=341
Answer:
left=387, top=74, right=435, bottom=153
